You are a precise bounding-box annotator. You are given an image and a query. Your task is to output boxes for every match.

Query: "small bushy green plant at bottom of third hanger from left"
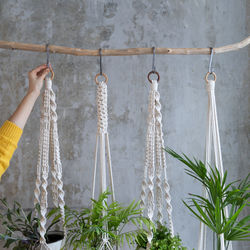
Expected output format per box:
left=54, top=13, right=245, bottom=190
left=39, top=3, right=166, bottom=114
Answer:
left=135, top=222, right=187, bottom=250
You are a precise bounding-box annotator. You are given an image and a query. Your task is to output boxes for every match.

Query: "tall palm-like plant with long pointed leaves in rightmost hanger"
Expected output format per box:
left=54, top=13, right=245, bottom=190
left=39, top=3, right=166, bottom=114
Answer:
left=166, top=149, right=250, bottom=250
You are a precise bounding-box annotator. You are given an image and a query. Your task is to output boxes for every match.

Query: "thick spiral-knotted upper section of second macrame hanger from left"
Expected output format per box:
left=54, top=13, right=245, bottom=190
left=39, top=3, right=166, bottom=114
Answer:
left=97, top=82, right=108, bottom=133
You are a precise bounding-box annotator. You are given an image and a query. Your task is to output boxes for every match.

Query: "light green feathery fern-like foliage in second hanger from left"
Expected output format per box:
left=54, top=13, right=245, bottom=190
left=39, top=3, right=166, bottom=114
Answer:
left=64, top=192, right=152, bottom=249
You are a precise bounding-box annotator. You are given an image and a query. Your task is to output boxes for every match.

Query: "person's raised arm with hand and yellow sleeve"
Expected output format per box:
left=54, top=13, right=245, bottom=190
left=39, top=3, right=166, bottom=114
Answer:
left=0, top=65, right=49, bottom=178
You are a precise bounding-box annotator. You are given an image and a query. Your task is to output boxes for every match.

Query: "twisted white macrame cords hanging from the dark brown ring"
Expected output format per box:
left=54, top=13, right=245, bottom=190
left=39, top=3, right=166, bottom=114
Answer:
left=141, top=80, right=174, bottom=246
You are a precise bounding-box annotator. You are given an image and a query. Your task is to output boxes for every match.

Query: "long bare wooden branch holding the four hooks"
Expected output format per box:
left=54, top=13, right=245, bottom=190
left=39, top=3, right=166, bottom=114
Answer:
left=0, top=36, right=250, bottom=56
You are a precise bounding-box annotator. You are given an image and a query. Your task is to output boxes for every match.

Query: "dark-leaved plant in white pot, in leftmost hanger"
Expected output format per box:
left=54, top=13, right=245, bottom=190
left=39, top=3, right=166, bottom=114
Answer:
left=0, top=199, right=64, bottom=250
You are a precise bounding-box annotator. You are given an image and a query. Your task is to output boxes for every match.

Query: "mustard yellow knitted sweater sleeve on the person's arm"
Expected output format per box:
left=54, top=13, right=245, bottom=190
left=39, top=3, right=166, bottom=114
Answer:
left=0, top=121, right=23, bottom=179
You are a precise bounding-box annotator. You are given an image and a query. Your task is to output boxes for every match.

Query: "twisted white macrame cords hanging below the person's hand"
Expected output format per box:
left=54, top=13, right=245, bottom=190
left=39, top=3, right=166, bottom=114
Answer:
left=34, top=77, right=66, bottom=249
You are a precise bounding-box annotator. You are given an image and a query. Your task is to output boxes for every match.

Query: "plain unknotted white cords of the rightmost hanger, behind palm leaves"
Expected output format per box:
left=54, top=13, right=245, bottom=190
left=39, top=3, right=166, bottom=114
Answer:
left=198, top=77, right=232, bottom=250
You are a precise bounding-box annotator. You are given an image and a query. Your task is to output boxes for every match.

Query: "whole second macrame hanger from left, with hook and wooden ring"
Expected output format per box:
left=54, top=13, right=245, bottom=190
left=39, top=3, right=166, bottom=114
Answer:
left=92, top=49, right=115, bottom=250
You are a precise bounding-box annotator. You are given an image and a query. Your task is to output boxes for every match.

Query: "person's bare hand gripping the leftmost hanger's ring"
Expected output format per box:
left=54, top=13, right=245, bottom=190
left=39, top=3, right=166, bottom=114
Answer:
left=28, top=64, right=50, bottom=96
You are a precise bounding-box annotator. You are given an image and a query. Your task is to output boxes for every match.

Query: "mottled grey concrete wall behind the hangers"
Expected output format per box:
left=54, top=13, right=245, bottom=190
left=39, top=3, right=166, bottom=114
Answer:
left=0, top=0, right=250, bottom=249
